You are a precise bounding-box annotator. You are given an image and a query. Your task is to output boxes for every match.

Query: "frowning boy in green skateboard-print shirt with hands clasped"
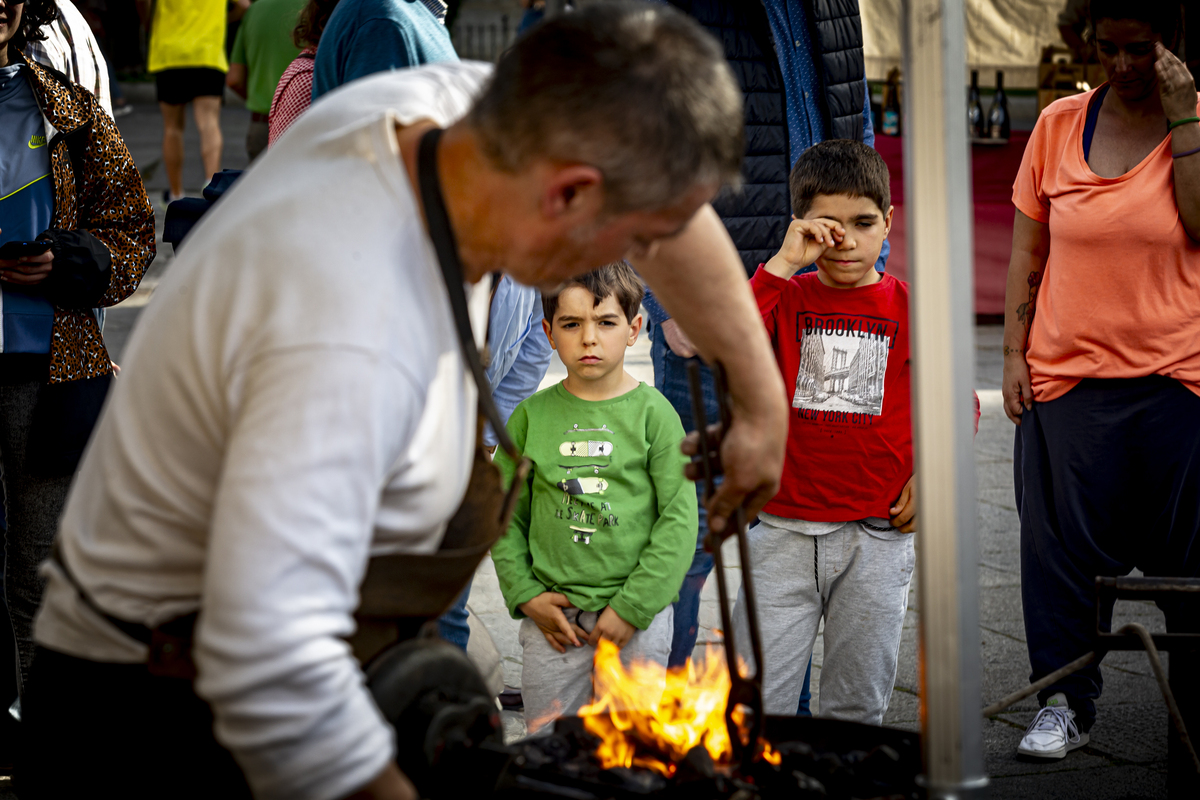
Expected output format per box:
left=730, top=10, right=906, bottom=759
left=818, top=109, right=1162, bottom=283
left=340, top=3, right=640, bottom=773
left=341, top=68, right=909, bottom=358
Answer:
left=492, top=263, right=697, bottom=733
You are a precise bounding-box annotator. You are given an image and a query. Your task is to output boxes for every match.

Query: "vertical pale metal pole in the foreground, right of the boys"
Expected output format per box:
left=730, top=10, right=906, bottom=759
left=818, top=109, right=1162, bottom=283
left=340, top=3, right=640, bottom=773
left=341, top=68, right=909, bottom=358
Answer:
left=902, top=0, right=988, bottom=798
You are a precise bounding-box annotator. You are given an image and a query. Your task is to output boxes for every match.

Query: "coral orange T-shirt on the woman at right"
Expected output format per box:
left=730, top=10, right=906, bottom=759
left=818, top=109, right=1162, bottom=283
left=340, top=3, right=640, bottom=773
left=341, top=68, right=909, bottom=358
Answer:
left=1013, top=90, right=1200, bottom=402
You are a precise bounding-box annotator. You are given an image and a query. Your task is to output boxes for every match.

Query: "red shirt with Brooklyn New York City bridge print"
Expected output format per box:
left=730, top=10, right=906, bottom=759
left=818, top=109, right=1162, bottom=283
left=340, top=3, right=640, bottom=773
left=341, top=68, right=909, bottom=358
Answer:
left=750, top=266, right=912, bottom=522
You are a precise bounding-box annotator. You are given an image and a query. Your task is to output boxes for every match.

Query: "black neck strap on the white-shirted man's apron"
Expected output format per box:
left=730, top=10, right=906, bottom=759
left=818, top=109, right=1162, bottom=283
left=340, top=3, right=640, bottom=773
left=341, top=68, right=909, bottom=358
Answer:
left=416, top=128, right=521, bottom=461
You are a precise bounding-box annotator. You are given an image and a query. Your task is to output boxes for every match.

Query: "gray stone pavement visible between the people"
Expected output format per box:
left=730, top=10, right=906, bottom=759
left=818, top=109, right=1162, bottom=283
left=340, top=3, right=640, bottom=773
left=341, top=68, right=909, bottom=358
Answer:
left=77, top=97, right=1169, bottom=800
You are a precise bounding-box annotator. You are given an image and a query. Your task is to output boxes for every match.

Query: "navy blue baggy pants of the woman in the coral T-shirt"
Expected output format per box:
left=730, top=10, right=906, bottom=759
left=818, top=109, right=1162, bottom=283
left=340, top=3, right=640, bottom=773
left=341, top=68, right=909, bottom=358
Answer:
left=1014, top=375, right=1200, bottom=730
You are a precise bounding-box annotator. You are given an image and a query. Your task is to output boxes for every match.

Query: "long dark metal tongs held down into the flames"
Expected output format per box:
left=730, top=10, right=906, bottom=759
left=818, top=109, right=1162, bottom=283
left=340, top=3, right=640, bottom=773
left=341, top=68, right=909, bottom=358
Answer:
left=688, top=361, right=763, bottom=771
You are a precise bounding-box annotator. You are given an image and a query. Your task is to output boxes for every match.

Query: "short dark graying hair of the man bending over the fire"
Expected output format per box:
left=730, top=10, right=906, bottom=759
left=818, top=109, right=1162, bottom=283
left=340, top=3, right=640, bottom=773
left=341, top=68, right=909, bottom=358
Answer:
left=468, top=2, right=745, bottom=212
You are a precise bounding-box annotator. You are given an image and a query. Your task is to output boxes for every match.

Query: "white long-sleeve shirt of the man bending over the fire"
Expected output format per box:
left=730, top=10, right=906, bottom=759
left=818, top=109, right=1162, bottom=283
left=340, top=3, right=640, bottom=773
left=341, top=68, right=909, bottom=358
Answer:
left=36, top=64, right=488, bottom=800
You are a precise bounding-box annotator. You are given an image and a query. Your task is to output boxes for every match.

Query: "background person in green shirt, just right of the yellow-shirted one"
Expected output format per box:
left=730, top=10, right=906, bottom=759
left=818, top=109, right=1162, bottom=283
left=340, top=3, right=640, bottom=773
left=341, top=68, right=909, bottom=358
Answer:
left=226, top=0, right=307, bottom=161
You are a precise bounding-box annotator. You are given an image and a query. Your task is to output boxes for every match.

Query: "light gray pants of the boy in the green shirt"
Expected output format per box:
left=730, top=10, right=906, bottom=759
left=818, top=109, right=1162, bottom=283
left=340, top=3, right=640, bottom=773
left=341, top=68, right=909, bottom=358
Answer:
left=518, top=606, right=674, bottom=734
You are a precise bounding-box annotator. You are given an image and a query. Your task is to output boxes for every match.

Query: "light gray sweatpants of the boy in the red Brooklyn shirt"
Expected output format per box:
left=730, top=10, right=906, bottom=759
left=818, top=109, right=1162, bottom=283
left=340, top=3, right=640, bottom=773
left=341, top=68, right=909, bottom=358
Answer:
left=733, top=521, right=916, bottom=724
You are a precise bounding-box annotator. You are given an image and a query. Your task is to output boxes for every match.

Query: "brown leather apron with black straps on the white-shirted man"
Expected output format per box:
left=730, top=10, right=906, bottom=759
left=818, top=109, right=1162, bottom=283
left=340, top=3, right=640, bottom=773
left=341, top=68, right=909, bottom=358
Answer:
left=52, top=128, right=529, bottom=679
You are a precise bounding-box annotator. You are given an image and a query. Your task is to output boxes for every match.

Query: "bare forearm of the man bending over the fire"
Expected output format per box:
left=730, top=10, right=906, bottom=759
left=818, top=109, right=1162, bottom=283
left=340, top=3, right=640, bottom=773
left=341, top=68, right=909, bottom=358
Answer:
left=634, top=205, right=786, bottom=419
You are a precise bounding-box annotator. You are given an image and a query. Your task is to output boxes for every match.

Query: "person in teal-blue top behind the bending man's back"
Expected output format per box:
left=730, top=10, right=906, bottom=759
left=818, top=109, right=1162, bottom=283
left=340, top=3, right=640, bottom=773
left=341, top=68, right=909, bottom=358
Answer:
left=312, top=0, right=458, bottom=103
